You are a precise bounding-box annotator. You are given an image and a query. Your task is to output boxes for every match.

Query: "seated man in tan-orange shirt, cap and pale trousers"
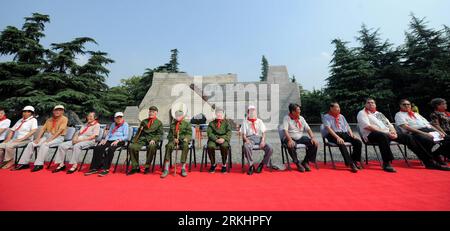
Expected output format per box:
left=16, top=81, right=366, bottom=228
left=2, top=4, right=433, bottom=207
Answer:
left=15, top=105, right=69, bottom=172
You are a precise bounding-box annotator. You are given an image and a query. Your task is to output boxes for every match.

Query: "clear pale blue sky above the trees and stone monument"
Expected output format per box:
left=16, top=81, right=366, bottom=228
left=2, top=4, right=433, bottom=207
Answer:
left=0, top=0, right=450, bottom=90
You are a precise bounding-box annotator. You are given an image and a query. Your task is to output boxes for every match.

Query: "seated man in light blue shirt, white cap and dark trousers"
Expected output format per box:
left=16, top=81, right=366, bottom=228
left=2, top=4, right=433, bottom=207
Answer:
left=84, top=112, right=128, bottom=177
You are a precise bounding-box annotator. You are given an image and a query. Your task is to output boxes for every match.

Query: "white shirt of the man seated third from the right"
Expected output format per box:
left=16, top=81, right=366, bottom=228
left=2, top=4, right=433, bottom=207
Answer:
left=356, top=109, right=392, bottom=141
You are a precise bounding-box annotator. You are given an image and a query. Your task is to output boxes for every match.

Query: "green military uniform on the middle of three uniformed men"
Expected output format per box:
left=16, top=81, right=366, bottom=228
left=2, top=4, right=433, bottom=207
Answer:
left=164, top=120, right=192, bottom=164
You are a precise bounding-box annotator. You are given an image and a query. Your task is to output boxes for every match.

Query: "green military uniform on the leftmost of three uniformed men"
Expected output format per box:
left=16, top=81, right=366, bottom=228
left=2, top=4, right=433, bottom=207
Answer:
left=129, top=118, right=163, bottom=169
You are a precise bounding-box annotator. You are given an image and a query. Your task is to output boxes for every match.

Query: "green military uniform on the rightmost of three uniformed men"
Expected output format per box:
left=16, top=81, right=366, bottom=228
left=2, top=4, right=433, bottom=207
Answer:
left=206, top=119, right=231, bottom=165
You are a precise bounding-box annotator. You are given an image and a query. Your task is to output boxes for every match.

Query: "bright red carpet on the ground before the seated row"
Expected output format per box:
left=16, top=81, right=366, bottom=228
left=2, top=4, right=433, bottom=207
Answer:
left=0, top=161, right=450, bottom=211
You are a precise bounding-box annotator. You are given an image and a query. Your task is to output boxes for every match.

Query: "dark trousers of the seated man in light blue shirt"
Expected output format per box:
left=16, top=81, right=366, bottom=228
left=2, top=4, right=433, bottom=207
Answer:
left=89, top=141, right=125, bottom=170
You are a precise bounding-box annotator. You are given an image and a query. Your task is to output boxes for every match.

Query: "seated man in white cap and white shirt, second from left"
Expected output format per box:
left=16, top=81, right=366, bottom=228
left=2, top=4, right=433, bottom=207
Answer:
left=0, top=106, right=38, bottom=169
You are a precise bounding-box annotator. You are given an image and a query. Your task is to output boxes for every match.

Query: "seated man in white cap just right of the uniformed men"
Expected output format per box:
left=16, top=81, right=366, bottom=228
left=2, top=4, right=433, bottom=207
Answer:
left=241, top=105, right=273, bottom=175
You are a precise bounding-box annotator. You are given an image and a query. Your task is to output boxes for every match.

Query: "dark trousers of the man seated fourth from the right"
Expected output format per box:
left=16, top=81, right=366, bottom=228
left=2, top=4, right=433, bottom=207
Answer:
left=326, top=132, right=362, bottom=166
